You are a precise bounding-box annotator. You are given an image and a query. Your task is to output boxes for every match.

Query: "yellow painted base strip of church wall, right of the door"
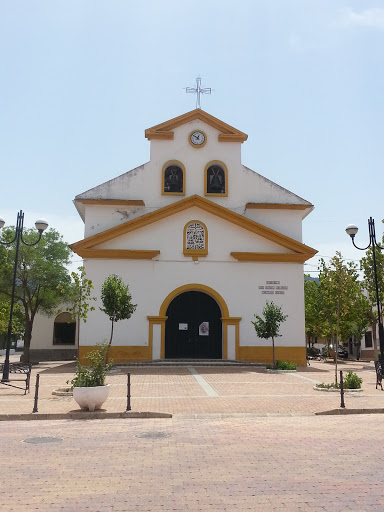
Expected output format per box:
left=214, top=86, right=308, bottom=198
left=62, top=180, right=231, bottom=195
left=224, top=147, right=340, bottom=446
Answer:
left=238, top=347, right=307, bottom=366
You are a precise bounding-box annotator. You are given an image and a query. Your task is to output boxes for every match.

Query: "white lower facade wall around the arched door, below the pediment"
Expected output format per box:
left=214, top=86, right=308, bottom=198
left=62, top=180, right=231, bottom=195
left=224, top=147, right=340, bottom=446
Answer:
left=80, top=258, right=305, bottom=346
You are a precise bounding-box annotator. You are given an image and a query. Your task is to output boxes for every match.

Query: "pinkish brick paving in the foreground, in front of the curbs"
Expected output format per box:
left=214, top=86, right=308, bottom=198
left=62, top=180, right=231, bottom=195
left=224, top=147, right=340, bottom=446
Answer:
left=0, top=415, right=384, bottom=512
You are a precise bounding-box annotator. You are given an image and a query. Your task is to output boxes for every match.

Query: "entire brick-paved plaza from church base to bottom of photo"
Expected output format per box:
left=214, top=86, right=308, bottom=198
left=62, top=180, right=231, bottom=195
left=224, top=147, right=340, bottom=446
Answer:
left=0, top=361, right=384, bottom=512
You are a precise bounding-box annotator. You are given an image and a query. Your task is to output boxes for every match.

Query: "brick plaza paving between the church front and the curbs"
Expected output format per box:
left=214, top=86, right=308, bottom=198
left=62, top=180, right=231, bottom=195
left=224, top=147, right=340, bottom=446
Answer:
left=0, top=361, right=384, bottom=415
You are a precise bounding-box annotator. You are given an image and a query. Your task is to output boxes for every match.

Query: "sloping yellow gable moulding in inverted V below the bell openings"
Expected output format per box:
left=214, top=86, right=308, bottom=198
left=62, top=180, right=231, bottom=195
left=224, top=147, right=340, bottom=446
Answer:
left=70, top=195, right=317, bottom=261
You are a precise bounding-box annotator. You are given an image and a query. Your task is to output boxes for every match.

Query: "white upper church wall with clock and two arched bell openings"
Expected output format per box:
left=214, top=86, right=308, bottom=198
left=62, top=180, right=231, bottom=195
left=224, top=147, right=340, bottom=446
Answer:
left=77, top=120, right=306, bottom=241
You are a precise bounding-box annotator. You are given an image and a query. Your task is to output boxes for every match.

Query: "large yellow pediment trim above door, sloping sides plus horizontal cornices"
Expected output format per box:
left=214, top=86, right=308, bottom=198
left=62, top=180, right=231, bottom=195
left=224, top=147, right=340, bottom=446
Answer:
left=71, top=195, right=317, bottom=262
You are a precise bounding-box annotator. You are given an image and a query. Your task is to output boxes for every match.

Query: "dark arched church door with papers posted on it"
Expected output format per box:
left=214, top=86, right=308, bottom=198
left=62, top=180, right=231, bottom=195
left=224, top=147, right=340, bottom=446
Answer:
left=165, top=292, right=222, bottom=359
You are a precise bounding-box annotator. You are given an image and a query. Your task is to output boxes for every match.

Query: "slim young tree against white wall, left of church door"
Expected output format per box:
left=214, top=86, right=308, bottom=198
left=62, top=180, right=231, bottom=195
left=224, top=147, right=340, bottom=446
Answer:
left=100, top=274, right=137, bottom=362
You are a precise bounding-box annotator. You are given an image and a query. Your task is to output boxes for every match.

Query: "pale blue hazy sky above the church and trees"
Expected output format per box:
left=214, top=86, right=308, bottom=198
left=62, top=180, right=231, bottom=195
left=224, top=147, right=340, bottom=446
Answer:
left=0, top=0, right=384, bottom=275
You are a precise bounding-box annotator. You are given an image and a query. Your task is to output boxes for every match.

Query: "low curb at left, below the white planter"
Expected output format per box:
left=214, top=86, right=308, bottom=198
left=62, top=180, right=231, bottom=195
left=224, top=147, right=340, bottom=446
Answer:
left=0, top=411, right=172, bottom=421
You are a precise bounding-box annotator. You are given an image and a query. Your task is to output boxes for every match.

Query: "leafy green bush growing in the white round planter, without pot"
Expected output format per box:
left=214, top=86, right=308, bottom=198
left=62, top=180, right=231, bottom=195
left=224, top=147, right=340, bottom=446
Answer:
left=71, top=341, right=113, bottom=388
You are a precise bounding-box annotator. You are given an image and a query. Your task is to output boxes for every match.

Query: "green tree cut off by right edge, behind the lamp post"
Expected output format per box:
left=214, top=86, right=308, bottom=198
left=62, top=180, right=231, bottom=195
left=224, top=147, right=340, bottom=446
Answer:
left=360, top=247, right=384, bottom=360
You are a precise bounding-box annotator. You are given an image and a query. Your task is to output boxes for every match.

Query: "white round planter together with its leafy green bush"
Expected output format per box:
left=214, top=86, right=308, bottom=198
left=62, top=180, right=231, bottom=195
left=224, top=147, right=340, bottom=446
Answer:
left=71, top=342, right=113, bottom=411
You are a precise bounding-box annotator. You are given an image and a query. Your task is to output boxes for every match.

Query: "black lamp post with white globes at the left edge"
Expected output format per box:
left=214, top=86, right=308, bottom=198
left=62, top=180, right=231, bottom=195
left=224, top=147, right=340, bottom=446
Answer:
left=0, top=210, right=48, bottom=382
